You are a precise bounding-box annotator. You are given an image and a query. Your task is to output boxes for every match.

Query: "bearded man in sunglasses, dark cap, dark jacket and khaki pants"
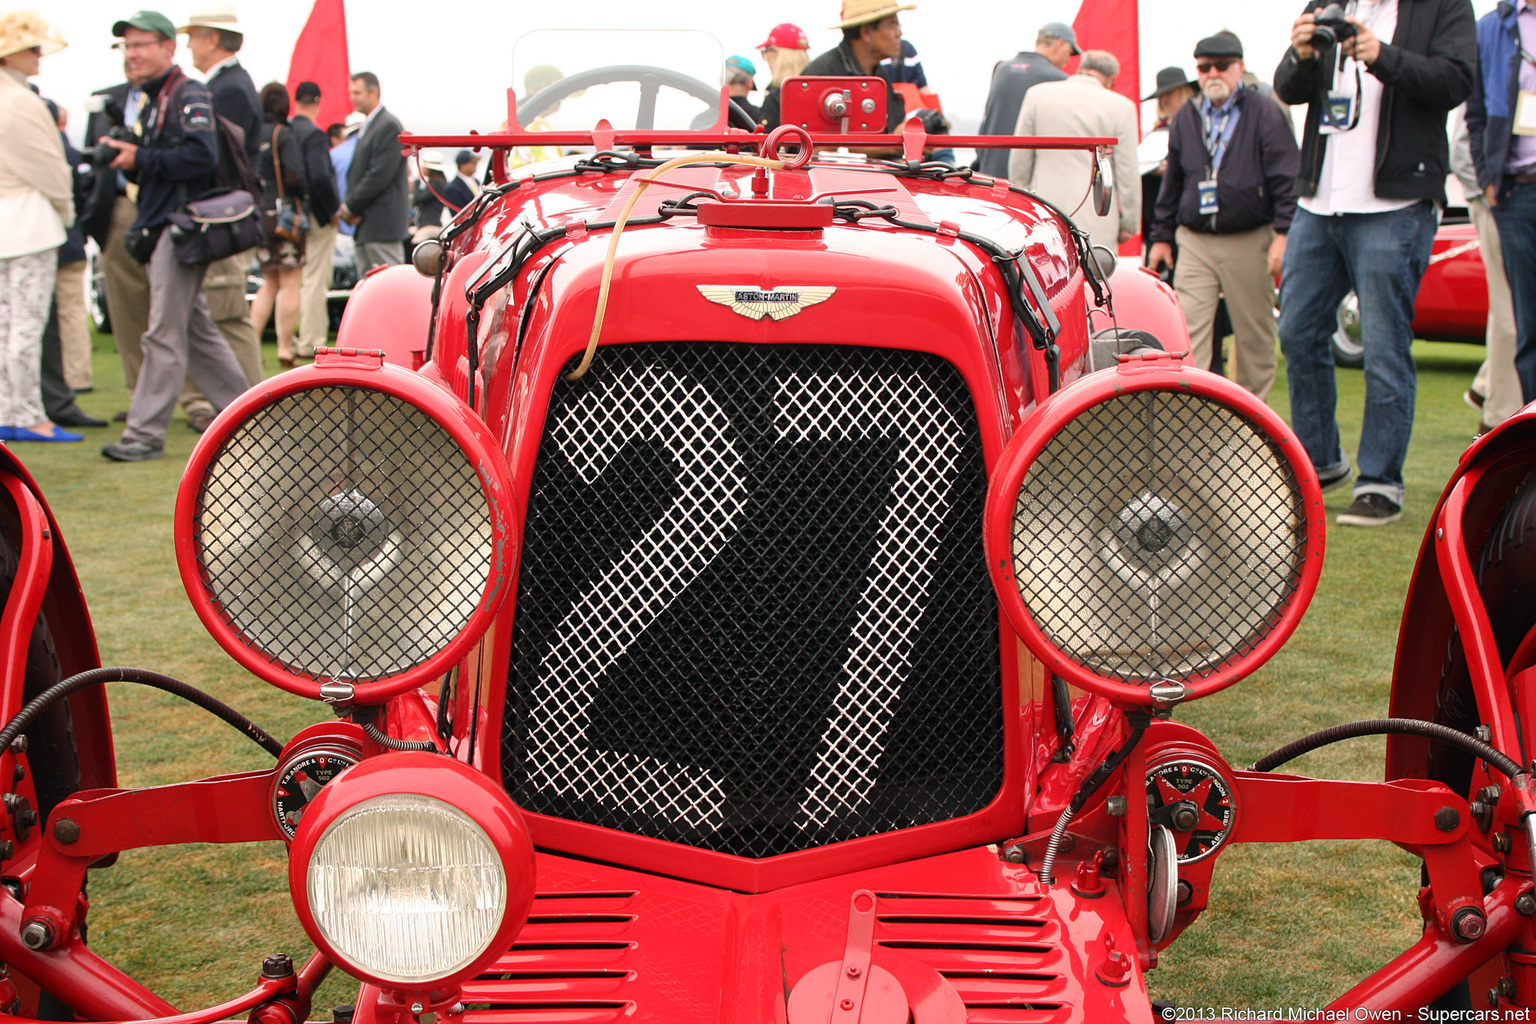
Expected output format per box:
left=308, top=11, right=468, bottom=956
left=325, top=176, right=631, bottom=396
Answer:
left=1147, top=34, right=1296, bottom=399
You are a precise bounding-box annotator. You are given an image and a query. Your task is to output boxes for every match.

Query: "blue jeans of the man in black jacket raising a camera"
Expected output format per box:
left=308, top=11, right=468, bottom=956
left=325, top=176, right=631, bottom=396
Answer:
left=1279, top=201, right=1439, bottom=505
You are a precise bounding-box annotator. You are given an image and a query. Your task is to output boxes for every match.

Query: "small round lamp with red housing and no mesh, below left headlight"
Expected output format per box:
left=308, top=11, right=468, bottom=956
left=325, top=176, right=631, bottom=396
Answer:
left=289, top=754, right=533, bottom=989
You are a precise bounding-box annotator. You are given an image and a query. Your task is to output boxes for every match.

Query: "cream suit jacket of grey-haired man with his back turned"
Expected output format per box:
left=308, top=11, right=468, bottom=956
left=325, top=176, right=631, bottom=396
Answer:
left=1008, top=74, right=1141, bottom=252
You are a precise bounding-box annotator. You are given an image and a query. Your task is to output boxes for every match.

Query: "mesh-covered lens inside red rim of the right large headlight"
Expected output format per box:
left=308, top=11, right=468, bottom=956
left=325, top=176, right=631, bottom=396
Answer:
left=1014, top=391, right=1307, bottom=683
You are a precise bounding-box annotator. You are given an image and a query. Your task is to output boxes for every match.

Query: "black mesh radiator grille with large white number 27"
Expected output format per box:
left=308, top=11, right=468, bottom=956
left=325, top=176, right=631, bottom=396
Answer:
left=504, top=342, right=1001, bottom=857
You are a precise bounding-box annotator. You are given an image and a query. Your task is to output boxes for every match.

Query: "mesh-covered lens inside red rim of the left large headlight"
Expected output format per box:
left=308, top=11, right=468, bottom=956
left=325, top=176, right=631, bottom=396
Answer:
left=195, top=387, right=492, bottom=682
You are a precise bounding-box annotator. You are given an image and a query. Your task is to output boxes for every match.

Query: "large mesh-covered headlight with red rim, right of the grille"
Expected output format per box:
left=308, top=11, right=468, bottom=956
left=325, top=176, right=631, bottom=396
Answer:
left=988, top=362, right=1324, bottom=703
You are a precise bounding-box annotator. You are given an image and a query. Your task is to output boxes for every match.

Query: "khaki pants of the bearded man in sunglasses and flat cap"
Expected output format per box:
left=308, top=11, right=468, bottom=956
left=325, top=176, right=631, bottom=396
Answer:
left=1174, top=224, right=1276, bottom=401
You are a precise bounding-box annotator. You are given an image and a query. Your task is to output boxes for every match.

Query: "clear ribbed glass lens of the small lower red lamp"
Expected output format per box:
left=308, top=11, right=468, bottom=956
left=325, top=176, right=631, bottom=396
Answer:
left=306, top=794, right=507, bottom=984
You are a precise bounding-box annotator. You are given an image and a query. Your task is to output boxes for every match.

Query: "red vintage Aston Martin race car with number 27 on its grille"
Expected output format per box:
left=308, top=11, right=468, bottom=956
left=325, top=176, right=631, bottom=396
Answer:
left=0, top=62, right=1536, bottom=1024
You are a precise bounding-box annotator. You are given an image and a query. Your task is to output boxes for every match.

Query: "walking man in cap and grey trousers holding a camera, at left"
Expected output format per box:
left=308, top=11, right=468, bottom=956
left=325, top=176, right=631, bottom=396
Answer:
left=100, top=11, right=246, bottom=462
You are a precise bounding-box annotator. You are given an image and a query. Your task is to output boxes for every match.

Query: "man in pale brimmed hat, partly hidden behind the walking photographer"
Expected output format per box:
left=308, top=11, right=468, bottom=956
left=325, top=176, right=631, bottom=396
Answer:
left=181, top=0, right=266, bottom=423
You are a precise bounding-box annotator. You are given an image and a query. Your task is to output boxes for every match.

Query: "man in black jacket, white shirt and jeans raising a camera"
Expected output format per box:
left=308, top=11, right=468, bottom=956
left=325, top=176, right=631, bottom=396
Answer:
left=1275, top=0, right=1478, bottom=527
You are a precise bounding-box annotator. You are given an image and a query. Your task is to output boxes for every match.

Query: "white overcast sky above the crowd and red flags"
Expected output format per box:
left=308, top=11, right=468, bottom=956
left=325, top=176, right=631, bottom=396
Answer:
left=33, top=0, right=1495, bottom=145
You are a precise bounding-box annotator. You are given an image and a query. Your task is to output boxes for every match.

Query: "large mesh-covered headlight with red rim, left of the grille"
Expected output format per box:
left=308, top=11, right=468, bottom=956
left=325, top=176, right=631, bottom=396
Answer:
left=177, top=359, right=516, bottom=700
